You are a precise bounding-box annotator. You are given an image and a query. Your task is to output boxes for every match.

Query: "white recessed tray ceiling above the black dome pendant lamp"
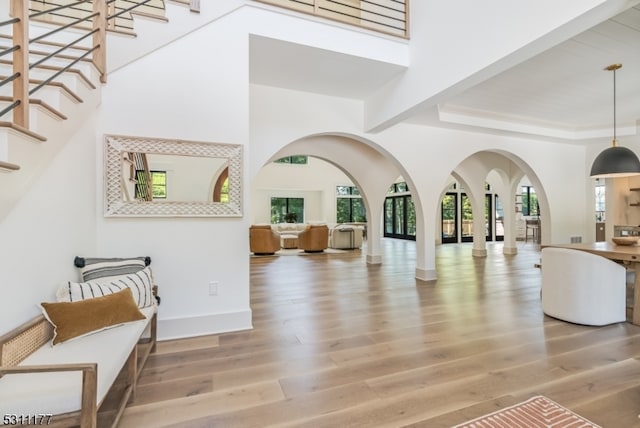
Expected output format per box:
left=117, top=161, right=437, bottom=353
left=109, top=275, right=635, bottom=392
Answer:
left=410, top=7, right=640, bottom=140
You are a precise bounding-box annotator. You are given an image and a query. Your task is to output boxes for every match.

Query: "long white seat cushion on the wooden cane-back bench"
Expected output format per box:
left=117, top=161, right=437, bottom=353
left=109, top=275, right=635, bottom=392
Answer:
left=0, top=306, right=156, bottom=415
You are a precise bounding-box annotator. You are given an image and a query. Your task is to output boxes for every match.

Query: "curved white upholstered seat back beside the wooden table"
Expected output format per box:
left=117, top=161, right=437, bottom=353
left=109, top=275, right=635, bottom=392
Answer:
left=541, top=247, right=626, bottom=325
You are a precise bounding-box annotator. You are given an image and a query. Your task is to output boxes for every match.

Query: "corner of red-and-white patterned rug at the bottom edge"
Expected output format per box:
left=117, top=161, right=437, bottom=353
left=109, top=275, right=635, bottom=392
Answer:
left=453, top=395, right=601, bottom=428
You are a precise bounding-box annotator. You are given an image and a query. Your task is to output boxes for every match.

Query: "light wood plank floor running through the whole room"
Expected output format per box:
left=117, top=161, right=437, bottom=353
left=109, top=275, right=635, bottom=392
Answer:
left=120, top=240, right=640, bottom=428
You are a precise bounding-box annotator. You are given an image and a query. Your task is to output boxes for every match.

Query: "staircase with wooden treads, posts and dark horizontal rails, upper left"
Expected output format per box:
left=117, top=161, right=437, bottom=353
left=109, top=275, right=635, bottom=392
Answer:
left=0, top=0, right=197, bottom=221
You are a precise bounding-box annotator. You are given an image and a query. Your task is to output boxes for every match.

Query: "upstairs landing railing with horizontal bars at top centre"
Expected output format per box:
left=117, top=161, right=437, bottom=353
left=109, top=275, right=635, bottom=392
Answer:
left=256, top=0, right=408, bottom=38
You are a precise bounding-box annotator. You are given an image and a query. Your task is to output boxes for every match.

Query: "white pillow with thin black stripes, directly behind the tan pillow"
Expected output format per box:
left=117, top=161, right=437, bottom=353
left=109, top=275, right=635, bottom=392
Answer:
left=56, top=266, right=156, bottom=308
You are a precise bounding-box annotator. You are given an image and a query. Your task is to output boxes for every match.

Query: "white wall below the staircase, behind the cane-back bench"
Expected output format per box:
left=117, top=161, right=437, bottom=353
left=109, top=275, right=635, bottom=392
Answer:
left=0, top=116, right=97, bottom=335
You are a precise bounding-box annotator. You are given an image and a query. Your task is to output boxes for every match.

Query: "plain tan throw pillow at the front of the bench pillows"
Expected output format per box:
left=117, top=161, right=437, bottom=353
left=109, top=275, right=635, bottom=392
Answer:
left=40, top=288, right=145, bottom=345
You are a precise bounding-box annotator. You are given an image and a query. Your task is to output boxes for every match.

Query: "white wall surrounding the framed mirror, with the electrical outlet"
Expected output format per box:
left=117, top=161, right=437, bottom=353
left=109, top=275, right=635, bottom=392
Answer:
left=96, top=10, right=251, bottom=338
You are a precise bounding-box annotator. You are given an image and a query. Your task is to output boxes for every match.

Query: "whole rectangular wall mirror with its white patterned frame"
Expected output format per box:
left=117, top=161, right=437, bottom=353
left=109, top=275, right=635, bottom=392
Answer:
left=104, top=135, right=242, bottom=217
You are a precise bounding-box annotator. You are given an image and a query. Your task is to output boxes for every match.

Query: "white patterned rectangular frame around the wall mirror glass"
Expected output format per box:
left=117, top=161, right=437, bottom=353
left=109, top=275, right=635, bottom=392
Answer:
left=104, top=135, right=242, bottom=217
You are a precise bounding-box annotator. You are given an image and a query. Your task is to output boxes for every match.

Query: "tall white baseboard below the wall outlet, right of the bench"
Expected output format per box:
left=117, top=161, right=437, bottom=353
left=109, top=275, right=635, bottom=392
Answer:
left=158, top=310, right=253, bottom=340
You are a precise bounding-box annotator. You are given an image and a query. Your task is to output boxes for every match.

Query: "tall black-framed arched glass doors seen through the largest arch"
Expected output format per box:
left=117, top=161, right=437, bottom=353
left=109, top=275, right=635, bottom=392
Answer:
left=384, top=182, right=416, bottom=240
